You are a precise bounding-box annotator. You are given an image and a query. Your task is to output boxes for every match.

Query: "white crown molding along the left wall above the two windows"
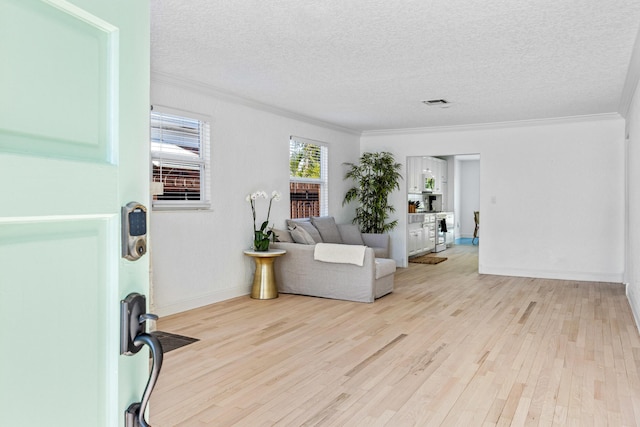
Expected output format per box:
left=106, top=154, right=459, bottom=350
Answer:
left=151, top=71, right=362, bottom=136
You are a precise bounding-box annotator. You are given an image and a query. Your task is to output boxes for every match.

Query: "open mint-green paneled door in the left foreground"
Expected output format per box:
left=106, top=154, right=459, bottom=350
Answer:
left=0, top=0, right=149, bottom=427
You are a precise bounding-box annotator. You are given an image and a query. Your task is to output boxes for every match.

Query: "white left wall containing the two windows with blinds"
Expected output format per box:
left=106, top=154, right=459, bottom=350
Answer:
left=150, top=79, right=360, bottom=315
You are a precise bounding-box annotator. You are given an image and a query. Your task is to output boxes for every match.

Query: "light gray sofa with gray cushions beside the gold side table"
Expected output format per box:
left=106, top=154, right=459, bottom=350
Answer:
left=271, top=217, right=396, bottom=302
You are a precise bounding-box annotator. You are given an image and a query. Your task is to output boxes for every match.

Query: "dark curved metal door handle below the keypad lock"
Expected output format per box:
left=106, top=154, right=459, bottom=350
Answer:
left=120, top=293, right=163, bottom=427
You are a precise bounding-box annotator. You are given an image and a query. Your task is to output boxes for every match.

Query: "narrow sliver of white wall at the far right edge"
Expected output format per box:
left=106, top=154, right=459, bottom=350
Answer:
left=625, top=79, right=640, bottom=329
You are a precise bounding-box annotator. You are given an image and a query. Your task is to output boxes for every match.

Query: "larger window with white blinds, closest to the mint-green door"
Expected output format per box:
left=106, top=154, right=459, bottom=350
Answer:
left=151, top=110, right=209, bottom=208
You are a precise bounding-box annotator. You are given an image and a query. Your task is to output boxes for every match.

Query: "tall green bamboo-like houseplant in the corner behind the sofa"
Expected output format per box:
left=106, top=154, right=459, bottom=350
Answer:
left=342, top=152, right=402, bottom=233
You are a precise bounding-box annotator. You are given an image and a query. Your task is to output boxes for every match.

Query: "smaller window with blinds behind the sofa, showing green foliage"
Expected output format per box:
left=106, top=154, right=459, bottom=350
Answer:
left=289, top=136, right=329, bottom=218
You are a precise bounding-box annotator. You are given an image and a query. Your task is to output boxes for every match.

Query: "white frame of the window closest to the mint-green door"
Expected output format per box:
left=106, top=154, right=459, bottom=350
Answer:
left=149, top=105, right=211, bottom=210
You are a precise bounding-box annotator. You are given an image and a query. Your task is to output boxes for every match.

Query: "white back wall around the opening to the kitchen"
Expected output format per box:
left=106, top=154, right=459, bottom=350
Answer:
left=361, top=115, right=625, bottom=282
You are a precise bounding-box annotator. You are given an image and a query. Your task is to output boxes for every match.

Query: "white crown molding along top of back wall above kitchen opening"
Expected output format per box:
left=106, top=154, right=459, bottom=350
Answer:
left=362, top=113, right=623, bottom=136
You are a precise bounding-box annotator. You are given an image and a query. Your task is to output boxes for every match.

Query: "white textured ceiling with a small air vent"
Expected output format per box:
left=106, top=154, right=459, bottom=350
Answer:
left=151, top=0, right=640, bottom=131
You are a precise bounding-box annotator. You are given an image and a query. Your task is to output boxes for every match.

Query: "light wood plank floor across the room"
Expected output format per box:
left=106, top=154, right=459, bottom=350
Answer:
left=150, top=246, right=640, bottom=427
